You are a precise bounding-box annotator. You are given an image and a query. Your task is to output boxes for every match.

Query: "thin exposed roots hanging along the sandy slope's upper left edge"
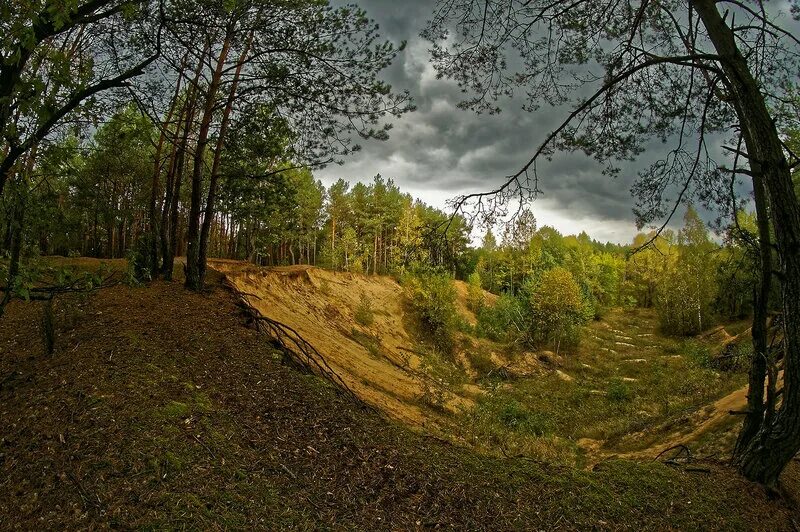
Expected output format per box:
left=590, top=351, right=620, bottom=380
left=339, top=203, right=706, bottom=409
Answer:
left=225, top=279, right=362, bottom=408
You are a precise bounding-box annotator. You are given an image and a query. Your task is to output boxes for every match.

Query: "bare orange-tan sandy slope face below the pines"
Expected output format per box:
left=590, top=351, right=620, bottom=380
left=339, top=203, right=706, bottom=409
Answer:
left=210, top=260, right=475, bottom=428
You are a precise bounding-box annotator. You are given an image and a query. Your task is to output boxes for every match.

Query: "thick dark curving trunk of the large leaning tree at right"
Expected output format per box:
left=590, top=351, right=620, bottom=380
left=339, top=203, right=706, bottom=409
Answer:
left=692, top=0, right=800, bottom=488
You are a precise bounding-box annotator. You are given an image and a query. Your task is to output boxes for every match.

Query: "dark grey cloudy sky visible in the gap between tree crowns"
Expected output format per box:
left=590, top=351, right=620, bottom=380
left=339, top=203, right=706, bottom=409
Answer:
left=317, top=0, right=780, bottom=242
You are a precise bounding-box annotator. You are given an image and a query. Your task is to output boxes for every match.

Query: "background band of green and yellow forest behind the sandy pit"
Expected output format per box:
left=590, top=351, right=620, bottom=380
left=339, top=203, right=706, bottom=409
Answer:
left=0, top=102, right=755, bottom=340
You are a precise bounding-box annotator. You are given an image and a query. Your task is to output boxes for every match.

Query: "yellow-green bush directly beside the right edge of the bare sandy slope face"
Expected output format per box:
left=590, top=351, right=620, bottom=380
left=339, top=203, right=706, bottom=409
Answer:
left=401, top=273, right=459, bottom=353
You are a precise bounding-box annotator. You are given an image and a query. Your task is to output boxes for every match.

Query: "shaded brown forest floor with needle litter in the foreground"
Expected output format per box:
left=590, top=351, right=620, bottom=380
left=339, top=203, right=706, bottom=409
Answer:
left=0, top=261, right=800, bottom=530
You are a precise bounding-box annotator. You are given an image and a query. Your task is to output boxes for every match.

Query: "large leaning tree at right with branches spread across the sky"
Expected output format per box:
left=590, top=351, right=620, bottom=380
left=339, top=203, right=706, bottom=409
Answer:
left=423, top=0, right=800, bottom=487
